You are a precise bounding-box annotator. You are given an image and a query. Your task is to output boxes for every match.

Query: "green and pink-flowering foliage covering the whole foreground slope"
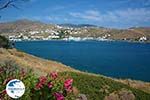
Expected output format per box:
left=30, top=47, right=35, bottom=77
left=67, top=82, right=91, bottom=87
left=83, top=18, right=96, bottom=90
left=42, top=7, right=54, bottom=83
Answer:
left=0, top=61, right=150, bottom=100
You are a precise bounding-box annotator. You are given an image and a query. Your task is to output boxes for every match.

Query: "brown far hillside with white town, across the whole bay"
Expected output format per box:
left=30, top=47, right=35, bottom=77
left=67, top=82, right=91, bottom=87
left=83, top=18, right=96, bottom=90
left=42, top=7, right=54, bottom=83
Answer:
left=0, top=20, right=150, bottom=42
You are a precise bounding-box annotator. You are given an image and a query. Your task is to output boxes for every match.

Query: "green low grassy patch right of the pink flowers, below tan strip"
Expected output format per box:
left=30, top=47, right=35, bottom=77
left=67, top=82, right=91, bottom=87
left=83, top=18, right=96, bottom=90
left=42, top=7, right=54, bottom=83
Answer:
left=61, top=72, right=150, bottom=100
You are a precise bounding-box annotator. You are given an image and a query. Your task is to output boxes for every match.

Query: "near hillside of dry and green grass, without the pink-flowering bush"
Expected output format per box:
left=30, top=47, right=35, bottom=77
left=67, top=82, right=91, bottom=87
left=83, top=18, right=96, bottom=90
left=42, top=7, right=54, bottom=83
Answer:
left=0, top=48, right=150, bottom=100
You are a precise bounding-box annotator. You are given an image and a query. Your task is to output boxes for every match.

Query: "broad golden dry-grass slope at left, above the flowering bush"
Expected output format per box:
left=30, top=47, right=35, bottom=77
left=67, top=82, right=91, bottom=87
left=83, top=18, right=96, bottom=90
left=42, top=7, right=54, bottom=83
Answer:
left=0, top=48, right=75, bottom=75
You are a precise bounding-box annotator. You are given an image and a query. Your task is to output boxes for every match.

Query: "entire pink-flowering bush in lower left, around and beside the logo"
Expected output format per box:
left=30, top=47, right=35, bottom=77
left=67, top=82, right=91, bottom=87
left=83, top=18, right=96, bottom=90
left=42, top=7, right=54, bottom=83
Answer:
left=0, top=62, right=74, bottom=100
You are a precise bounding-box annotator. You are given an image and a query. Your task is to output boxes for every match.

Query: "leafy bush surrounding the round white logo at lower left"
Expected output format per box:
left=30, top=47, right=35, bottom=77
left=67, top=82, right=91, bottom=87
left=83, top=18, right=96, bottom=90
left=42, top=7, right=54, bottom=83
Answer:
left=0, top=61, right=36, bottom=100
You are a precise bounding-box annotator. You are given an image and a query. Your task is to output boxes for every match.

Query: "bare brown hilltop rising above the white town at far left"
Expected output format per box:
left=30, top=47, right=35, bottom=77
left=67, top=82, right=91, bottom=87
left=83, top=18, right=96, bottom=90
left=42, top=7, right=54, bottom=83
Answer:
left=0, top=19, right=54, bottom=33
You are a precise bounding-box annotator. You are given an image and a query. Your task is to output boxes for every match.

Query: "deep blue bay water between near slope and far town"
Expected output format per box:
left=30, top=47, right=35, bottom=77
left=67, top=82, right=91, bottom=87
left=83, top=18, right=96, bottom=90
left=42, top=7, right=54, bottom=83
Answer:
left=16, top=41, right=150, bottom=81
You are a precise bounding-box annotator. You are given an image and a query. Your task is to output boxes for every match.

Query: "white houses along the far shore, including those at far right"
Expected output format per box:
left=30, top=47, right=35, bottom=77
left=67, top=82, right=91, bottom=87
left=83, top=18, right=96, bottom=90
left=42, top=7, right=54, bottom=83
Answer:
left=9, top=26, right=147, bottom=41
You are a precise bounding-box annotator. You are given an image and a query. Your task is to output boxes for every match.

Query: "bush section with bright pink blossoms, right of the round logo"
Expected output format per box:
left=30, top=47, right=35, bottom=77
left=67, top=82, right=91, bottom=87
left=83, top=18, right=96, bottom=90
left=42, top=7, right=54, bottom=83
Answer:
left=33, top=72, right=73, bottom=100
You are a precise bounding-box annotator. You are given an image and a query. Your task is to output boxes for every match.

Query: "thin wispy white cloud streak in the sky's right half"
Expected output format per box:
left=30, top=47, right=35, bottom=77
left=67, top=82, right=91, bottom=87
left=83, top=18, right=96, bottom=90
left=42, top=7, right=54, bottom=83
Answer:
left=70, top=8, right=150, bottom=24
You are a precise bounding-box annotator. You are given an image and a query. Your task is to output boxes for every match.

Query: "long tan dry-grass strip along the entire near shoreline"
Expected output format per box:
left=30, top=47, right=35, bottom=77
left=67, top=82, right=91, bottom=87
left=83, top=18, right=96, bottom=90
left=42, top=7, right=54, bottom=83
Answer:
left=0, top=48, right=150, bottom=93
